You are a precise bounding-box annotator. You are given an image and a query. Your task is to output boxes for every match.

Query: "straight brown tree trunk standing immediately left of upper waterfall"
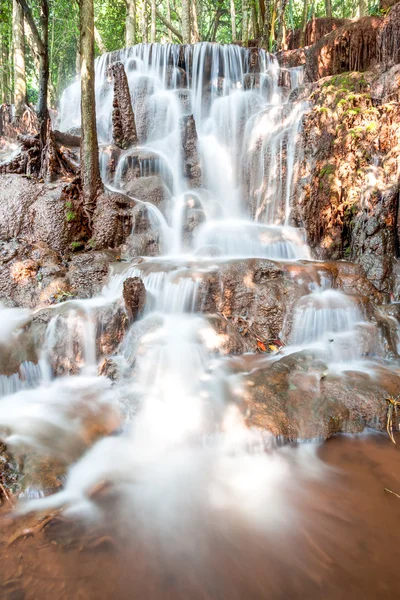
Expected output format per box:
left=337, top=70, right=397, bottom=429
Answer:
left=80, top=0, right=103, bottom=223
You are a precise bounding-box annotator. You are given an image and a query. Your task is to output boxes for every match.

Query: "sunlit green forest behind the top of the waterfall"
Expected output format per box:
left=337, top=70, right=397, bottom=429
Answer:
left=0, top=0, right=386, bottom=106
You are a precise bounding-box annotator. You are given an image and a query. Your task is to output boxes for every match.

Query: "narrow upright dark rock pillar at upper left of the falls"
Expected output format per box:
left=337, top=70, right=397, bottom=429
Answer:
left=108, top=62, right=138, bottom=149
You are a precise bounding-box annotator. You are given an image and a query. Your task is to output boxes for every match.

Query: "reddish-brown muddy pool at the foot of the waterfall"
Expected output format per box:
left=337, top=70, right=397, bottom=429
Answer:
left=0, top=434, right=400, bottom=600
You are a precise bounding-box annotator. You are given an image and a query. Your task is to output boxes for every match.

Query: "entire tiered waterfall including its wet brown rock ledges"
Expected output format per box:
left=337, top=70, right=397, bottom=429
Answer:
left=0, top=37, right=400, bottom=598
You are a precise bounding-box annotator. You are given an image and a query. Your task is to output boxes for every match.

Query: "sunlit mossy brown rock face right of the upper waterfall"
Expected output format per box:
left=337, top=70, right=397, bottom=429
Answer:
left=293, top=72, right=400, bottom=293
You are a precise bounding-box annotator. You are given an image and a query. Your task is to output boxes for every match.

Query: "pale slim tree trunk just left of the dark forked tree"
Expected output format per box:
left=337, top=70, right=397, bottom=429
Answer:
left=13, top=0, right=26, bottom=117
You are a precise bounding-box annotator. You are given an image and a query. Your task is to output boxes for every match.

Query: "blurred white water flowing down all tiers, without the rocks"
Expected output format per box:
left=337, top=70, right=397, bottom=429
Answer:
left=0, top=43, right=400, bottom=598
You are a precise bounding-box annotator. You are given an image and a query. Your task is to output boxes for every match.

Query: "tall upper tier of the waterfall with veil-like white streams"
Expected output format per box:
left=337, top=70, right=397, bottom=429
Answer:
left=59, top=43, right=308, bottom=259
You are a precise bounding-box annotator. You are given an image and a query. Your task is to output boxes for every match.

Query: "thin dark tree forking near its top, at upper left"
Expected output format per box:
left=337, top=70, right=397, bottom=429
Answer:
left=17, top=0, right=49, bottom=145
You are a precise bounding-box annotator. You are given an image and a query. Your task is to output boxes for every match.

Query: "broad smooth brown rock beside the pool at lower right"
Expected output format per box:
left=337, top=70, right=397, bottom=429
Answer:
left=242, top=351, right=400, bottom=440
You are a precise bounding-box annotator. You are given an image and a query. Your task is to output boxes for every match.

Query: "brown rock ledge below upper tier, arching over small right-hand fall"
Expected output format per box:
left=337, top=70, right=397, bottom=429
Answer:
left=191, top=259, right=391, bottom=353
